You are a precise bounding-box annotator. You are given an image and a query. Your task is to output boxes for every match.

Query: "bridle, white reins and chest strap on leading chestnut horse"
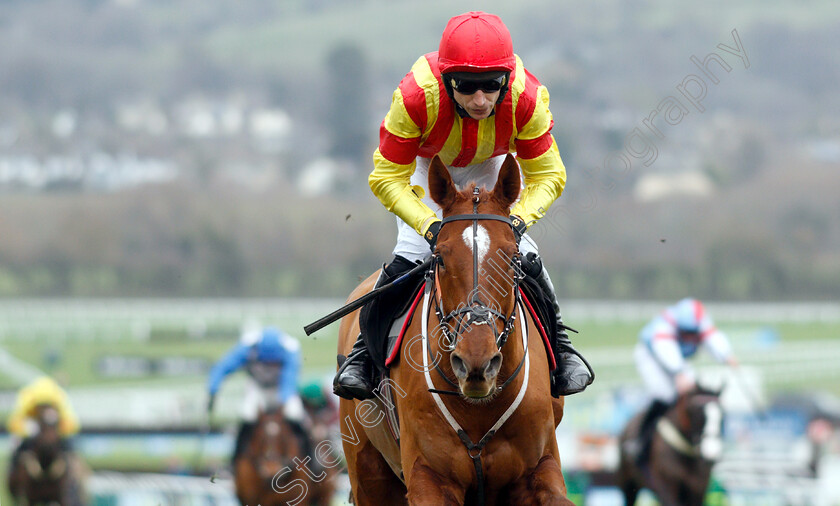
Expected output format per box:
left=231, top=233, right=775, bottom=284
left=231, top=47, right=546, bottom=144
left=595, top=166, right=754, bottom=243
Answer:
left=421, top=188, right=531, bottom=505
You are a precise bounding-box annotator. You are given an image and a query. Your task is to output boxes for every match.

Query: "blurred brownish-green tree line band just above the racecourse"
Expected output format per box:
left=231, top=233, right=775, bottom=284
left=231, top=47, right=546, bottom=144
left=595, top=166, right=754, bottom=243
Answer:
left=0, top=156, right=840, bottom=300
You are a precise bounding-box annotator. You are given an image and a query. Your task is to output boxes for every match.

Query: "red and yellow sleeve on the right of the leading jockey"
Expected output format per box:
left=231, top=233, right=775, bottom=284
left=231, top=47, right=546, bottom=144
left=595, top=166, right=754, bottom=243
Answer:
left=511, top=68, right=566, bottom=226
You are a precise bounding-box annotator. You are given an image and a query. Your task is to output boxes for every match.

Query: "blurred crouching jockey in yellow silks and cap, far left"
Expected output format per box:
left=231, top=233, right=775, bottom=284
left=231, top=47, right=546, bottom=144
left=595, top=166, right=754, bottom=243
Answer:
left=6, top=376, right=79, bottom=469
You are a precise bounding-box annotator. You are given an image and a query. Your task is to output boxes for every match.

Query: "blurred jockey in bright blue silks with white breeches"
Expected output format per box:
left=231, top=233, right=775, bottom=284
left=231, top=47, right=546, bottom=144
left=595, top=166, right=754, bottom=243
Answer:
left=207, top=327, right=308, bottom=461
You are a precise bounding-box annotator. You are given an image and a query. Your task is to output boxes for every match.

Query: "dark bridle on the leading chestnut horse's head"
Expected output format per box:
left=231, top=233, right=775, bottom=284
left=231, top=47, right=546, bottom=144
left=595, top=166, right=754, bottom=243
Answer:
left=432, top=187, right=523, bottom=351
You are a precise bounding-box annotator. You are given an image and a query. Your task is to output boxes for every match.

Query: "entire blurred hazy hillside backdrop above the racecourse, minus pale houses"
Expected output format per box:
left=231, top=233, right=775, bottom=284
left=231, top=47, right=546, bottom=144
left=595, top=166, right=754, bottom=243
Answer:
left=0, top=0, right=840, bottom=300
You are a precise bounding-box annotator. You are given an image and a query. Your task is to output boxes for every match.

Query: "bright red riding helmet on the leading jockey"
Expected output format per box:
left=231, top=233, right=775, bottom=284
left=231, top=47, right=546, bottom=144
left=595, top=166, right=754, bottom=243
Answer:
left=438, top=12, right=516, bottom=74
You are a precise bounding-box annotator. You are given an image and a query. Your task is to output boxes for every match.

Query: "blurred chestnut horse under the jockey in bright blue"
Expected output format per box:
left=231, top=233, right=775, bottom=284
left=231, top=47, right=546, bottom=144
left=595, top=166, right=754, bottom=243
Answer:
left=234, top=406, right=335, bottom=506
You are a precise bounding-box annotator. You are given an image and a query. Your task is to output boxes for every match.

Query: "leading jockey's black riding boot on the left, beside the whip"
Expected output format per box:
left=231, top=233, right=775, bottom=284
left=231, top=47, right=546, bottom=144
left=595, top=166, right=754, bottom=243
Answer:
left=333, top=256, right=417, bottom=400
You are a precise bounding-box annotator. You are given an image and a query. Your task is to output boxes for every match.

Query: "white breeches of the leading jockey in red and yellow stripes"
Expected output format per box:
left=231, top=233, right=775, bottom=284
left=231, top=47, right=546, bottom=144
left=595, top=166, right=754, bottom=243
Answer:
left=394, top=155, right=537, bottom=262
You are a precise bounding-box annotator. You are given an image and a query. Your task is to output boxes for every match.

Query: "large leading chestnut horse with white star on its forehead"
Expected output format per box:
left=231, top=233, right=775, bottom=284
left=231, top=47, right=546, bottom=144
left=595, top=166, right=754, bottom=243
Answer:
left=338, top=155, right=572, bottom=506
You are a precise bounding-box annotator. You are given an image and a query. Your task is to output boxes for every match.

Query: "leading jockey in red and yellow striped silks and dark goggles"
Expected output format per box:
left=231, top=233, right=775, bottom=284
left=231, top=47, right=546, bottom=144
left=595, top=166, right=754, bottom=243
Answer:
left=333, top=12, right=593, bottom=399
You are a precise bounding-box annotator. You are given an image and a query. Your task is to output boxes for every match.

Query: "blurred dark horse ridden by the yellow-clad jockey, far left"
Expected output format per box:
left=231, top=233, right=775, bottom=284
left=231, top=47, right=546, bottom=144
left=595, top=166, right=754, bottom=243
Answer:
left=9, top=404, right=86, bottom=506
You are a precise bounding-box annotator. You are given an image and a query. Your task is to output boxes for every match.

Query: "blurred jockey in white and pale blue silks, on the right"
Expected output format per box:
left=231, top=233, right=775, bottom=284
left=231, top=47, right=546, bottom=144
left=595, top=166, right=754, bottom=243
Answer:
left=628, top=298, right=738, bottom=462
